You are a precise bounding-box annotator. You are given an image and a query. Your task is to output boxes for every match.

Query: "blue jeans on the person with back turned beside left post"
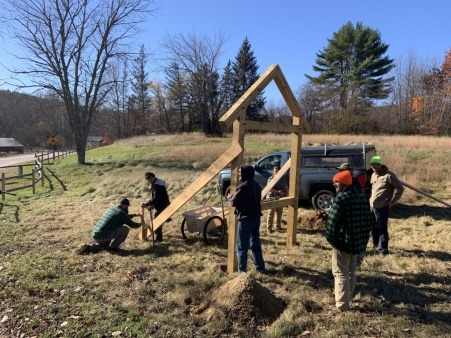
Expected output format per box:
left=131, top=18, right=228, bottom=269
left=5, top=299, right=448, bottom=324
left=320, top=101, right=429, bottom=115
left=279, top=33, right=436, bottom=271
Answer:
left=236, top=218, right=265, bottom=273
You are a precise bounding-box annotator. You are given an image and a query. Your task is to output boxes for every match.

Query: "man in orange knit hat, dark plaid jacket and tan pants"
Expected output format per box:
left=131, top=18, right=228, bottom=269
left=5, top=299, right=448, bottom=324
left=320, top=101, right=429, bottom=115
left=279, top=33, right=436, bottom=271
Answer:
left=326, top=171, right=373, bottom=311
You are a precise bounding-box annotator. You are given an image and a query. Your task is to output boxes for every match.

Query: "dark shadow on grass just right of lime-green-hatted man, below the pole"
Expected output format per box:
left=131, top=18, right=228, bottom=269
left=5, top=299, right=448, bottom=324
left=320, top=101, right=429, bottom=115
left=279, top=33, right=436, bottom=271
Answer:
left=390, top=204, right=451, bottom=221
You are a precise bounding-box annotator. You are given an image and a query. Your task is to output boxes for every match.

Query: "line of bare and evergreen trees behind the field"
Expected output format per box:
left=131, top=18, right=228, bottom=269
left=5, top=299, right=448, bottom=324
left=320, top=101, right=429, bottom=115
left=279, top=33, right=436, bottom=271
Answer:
left=0, top=0, right=451, bottom=163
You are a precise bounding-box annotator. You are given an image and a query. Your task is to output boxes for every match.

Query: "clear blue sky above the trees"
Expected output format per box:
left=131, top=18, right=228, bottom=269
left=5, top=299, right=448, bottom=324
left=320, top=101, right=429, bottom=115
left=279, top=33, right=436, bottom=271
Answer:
left=0, top=0, right=451, bottom=100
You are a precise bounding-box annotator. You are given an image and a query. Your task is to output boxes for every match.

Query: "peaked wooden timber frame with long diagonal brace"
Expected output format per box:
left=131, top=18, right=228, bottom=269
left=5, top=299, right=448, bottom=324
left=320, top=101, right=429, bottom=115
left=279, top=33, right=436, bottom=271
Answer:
left=140, top=65, right=311, bottom=273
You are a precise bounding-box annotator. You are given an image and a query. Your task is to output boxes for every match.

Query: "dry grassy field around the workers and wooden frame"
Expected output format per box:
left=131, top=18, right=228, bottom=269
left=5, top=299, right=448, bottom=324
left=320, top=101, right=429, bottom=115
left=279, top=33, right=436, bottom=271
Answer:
left=0, top=134, right=451, bottom=338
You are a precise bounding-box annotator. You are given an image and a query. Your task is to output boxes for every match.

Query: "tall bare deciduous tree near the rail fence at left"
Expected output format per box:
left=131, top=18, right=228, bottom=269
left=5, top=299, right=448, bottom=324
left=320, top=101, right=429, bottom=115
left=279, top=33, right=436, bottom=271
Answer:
left=3, top=0, right=153, bottom=164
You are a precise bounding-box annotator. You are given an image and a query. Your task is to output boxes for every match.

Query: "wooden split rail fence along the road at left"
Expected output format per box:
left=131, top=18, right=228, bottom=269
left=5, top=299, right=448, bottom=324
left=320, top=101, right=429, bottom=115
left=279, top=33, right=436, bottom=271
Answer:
left=0, top=150, right=75, bottom=201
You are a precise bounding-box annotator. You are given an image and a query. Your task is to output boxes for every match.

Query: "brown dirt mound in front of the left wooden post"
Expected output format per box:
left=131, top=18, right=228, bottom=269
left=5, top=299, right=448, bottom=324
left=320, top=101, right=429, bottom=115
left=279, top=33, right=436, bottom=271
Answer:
left=195, top=273, right=286, bottom=328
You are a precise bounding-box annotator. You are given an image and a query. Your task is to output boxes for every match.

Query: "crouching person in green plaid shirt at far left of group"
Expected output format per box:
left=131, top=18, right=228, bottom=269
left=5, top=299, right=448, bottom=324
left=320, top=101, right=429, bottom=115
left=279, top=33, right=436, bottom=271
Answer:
left=91, top=198, right=143, bottom=251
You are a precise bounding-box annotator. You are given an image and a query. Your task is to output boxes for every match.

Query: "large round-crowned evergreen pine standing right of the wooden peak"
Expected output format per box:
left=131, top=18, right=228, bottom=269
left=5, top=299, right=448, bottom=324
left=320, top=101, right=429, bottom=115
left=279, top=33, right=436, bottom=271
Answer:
left=306, top=22, right=394, bottom=114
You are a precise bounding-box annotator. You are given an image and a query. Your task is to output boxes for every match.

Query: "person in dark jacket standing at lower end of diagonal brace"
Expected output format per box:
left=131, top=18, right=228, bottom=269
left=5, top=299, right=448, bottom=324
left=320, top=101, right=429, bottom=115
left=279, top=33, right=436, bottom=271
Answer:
left=141, top=172, right=170, bottom=242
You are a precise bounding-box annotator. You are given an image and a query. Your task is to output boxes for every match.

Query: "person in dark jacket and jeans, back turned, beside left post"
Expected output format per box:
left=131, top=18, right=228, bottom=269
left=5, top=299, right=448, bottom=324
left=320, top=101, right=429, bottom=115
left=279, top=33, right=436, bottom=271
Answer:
left=227, top=165, right=266, bottom=273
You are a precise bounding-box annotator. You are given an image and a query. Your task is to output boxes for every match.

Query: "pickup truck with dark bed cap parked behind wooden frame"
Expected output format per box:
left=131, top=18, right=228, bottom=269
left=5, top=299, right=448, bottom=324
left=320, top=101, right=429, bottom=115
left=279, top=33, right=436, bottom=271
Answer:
left=218, top=144, right=376, bottom=211
